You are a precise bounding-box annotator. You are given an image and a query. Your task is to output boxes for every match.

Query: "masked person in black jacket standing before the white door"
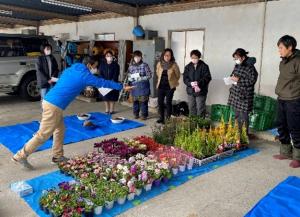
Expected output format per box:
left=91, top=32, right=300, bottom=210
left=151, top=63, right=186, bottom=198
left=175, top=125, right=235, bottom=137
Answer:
left=183, top=50, right=211, bottom=118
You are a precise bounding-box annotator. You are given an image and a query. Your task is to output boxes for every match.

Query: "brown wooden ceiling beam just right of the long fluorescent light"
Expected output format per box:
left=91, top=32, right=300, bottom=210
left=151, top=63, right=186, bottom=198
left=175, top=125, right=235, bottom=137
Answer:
left=61, top=0, right=137, bottom=17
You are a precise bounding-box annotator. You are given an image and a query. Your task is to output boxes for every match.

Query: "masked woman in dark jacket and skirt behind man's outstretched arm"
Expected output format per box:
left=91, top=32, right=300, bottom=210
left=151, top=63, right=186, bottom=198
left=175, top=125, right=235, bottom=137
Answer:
left=99, top=51, right=120, bottom=114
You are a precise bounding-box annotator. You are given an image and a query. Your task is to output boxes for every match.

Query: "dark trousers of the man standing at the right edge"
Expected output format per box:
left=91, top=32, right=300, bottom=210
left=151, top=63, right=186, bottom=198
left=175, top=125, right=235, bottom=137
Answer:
left=277, top=99, right=300, bottom=149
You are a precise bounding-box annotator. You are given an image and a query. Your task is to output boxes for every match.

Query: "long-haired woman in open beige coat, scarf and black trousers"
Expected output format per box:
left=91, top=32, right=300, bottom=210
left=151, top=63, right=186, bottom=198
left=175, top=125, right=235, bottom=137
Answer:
left=156, top=48, right=180, bottom=124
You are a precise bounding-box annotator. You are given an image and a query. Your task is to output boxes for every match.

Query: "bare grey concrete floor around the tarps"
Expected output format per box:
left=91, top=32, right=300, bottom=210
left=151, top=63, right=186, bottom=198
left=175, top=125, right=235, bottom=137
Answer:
left=0, top=94, right=300, bottom=217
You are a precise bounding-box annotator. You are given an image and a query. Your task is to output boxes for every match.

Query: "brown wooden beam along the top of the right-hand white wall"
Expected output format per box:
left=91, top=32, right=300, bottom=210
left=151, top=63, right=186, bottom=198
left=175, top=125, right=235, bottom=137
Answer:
left=139, top=0, right=265, bottom=16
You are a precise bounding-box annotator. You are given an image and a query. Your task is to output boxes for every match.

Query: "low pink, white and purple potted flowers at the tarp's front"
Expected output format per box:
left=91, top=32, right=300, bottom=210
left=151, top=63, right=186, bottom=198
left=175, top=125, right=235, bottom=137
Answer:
left=40, top=146, right=192, bottom=216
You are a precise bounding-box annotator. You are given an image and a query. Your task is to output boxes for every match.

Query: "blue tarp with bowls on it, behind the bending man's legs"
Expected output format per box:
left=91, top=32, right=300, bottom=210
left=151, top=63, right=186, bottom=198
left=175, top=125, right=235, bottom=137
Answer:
left=0, top=112, right=144, bottom=154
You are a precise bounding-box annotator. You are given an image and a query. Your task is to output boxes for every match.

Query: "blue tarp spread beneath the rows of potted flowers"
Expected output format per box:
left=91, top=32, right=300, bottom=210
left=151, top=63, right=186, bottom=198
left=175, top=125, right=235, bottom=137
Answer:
left=24, top=149, right=258, bottom=217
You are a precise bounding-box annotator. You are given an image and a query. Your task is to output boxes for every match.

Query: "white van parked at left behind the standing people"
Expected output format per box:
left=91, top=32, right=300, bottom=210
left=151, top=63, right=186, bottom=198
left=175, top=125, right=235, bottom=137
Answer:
left=0, top=34, right=61, bottom=101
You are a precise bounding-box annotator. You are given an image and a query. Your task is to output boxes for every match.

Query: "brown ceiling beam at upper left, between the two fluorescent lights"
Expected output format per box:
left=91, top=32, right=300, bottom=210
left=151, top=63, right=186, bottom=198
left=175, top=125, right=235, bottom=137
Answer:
left=0, top=4, right=78, bottom=22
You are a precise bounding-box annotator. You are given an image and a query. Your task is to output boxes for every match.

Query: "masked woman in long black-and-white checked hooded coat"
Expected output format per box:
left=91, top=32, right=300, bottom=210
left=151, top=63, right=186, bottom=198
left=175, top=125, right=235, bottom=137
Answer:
left=228, top=48, right=258, bottom=133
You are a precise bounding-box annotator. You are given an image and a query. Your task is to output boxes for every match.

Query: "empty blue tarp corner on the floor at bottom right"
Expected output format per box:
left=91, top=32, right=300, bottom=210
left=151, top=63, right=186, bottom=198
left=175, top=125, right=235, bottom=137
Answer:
left=245, top=176, right=300, bottom=217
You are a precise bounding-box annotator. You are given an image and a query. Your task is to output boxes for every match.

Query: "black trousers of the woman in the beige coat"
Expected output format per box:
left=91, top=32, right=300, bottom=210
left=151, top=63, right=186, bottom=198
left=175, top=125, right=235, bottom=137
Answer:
left=157, top=88, right=175, bottom=120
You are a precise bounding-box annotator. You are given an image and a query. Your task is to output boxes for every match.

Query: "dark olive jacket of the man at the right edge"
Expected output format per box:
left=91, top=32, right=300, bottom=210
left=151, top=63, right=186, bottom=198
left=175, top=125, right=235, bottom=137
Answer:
left=275, top=50, right=300, bottom=100
